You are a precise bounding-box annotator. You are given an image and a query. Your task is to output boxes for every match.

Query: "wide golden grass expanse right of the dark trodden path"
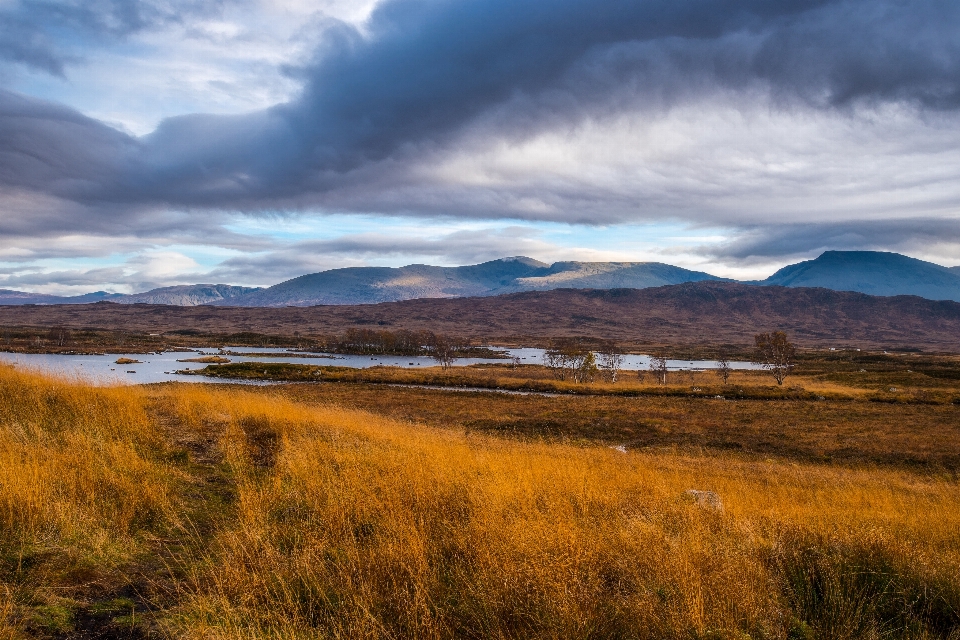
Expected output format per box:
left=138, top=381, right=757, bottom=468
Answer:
left=161, top=382, right=960, bottom=638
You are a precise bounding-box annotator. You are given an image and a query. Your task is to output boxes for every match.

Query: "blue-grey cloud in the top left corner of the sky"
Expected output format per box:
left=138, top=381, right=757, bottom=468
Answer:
left=0, top=0, right=221, bottom=76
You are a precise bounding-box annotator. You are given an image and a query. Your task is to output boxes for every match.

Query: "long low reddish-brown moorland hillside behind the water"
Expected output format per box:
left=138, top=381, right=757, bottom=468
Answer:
left=7, top=282, right=960, bottom=352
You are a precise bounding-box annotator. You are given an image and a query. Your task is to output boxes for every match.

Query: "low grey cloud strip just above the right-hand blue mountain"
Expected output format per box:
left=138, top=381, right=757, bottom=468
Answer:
left=703, top=218, right=960, bottom=261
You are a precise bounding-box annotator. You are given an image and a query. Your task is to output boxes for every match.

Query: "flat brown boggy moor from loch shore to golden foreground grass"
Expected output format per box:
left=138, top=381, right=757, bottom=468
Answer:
left=199, top=352, right=960, bottom=474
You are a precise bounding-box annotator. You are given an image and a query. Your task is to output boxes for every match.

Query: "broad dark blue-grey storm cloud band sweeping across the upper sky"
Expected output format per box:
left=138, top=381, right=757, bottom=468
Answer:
left=0, top=0, right=960, bottom=225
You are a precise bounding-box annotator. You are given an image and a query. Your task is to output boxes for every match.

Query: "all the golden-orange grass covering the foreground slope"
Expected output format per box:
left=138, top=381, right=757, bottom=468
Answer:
left=0, top=368, right=960, bottom=639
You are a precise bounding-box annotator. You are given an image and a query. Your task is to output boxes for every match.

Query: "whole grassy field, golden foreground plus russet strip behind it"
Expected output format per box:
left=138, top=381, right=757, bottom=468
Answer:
left=0, top=365, right=960, bottom=639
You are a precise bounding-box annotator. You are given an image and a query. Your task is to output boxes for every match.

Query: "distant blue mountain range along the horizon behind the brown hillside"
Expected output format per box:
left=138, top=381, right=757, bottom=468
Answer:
left=0, top=251, right=960, bottom=307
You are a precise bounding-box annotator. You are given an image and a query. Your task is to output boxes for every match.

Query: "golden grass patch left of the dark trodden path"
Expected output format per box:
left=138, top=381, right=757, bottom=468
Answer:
left=0, top=366, right=179, bottom=637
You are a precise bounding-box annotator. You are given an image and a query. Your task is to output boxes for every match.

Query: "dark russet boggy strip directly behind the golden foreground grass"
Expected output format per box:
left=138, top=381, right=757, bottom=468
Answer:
left=280, top=384, right=960, bottom=474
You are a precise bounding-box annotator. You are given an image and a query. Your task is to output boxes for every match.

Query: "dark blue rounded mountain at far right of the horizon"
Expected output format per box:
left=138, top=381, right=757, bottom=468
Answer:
left=758, top=251, right=960, bottom=300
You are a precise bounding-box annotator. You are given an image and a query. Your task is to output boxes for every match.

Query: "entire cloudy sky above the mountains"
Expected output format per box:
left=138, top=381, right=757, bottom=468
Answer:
left=0, top=0, right=960, bottom=294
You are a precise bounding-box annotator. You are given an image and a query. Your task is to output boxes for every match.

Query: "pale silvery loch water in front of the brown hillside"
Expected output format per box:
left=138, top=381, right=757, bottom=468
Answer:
left=0, top=347, right=756, bottom=384
